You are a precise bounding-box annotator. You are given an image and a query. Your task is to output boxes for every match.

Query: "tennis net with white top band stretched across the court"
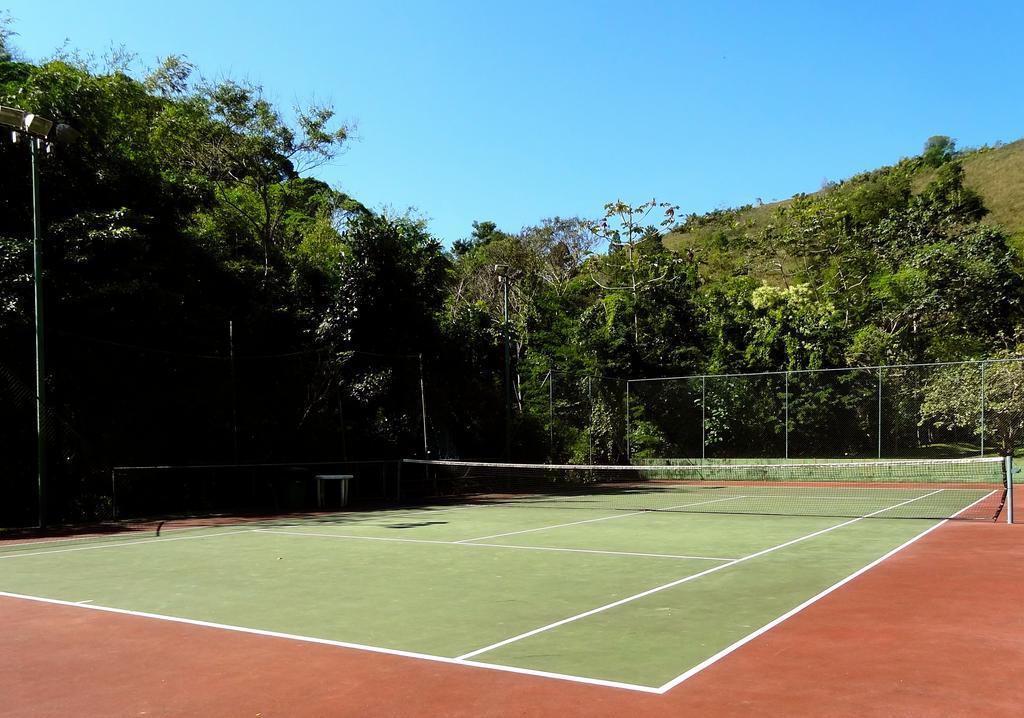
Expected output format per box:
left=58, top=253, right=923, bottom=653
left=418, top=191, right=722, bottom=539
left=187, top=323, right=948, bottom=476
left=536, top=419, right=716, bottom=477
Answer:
left=400, top=457, right=1013, bottom=521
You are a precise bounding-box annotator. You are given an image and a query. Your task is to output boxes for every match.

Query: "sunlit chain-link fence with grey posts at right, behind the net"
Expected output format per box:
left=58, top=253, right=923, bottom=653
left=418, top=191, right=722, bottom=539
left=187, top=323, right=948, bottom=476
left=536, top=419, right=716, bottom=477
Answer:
left=627, top=358, right=1024, bottom=461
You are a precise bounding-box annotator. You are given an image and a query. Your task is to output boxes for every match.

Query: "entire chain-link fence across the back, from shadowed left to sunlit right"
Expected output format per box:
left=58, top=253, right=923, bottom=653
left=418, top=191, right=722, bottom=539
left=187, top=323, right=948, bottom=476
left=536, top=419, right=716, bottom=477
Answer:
left=0, top=344, right=1024, bottom=525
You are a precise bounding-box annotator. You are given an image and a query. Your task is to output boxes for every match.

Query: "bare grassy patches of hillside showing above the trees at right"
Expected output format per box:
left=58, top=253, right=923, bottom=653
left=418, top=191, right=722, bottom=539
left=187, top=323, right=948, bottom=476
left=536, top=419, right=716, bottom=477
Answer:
left=665, top=134, right=1024, bottom=260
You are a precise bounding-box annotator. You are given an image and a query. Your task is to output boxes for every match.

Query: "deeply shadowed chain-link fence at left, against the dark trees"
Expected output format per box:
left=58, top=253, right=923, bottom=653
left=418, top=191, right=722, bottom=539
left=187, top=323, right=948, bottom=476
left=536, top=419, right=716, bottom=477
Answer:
left=0, top=332, right=426, bottom=526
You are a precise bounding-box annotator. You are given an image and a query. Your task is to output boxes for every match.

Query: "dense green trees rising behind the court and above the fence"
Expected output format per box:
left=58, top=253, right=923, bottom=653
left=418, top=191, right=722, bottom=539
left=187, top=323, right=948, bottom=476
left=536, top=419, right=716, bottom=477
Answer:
left=0, top=30, right=1024, bottom=522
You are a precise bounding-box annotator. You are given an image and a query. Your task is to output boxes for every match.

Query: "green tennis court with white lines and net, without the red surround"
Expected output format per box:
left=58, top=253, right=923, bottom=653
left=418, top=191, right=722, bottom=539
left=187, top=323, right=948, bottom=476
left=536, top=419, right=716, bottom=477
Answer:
left=0, top=459, right=1013, bottom=693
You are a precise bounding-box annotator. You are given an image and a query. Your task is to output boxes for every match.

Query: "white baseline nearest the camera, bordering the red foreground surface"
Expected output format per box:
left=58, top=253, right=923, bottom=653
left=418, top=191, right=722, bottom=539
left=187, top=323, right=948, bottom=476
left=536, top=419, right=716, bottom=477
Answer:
left=0, top=591, right=659, bottom=693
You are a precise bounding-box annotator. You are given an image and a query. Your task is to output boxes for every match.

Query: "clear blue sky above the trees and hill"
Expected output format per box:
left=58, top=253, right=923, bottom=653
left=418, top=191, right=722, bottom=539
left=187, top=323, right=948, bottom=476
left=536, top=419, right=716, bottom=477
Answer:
left=5, top=0, right=1024, bottom=243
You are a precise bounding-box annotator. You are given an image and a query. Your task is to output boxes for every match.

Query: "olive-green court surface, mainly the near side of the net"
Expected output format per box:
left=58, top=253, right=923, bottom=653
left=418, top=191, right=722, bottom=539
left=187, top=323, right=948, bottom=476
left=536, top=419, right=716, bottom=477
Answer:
left=0, top=488, right=984, bottom=691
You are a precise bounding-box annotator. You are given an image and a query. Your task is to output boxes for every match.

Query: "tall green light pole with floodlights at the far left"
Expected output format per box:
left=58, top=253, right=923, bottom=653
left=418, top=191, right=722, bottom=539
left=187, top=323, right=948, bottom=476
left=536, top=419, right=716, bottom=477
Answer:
left=0, top=105, right=78, bottom=529
